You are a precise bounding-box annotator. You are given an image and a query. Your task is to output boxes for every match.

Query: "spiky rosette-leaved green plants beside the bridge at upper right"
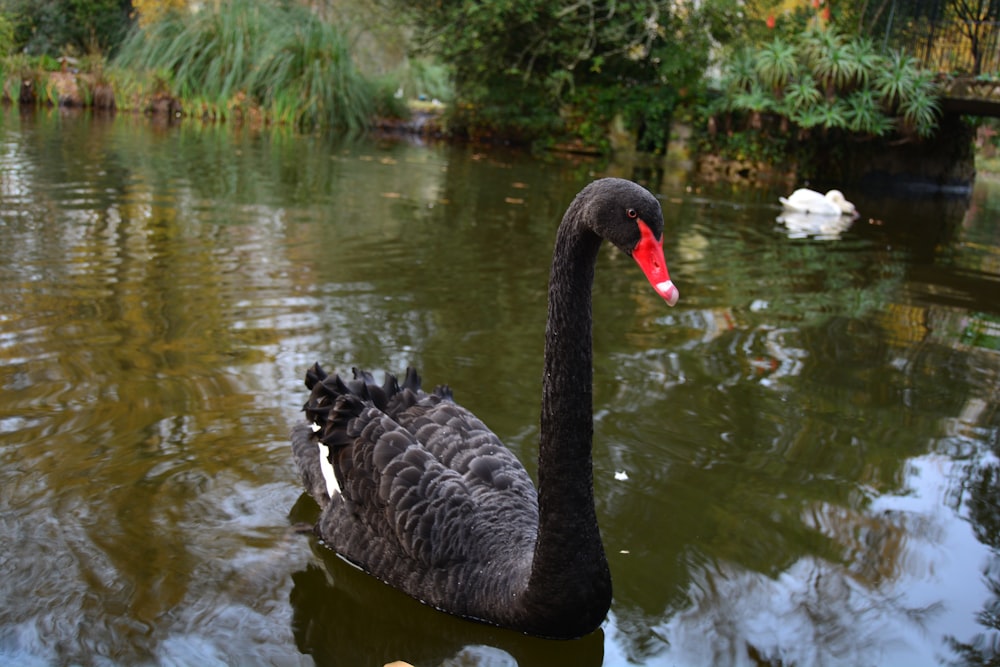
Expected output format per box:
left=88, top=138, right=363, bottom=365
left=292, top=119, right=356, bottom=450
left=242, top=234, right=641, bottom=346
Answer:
left=705, top=26, right=941, bottom=170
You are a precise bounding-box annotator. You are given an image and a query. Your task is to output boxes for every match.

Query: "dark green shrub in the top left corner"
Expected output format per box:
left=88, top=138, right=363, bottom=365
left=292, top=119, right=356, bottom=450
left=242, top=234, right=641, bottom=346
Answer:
left=0, top=0, right=132, bottom=56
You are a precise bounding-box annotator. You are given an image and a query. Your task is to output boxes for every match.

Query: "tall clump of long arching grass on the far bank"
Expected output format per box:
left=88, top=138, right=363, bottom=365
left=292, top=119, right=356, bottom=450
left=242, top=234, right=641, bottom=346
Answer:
left=115, top=0, right=376, bottom=130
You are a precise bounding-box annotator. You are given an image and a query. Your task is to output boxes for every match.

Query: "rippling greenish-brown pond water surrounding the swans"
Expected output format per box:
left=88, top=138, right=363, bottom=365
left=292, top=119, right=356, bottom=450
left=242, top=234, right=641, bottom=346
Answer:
left=0, top=110, right=1000, bottom=666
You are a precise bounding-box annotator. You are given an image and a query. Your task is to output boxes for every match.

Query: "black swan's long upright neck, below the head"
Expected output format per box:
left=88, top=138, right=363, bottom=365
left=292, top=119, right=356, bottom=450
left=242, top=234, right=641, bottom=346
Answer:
left=526, top=214, right=611, bottom=628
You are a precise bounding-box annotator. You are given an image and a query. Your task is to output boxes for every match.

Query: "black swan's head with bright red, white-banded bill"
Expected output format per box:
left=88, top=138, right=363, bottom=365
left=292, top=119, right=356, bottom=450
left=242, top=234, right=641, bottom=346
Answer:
left=578, top=178, right=680, bottom=306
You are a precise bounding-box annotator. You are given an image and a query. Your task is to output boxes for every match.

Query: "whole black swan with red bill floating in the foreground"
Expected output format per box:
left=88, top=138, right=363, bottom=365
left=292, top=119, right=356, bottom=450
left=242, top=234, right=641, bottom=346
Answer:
left=291, top=178, right=678, bottom=639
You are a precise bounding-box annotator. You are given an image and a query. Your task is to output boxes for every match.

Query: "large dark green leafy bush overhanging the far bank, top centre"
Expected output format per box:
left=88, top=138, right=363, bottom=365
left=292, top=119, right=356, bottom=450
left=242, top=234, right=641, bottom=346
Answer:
left=386, top=0, right=735, bottom=150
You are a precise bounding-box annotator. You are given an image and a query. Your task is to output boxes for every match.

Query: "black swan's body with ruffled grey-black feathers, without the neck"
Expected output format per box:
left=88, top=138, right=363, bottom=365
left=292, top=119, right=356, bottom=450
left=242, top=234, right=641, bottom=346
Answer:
left=292, top=364, right=538, bottom=618
